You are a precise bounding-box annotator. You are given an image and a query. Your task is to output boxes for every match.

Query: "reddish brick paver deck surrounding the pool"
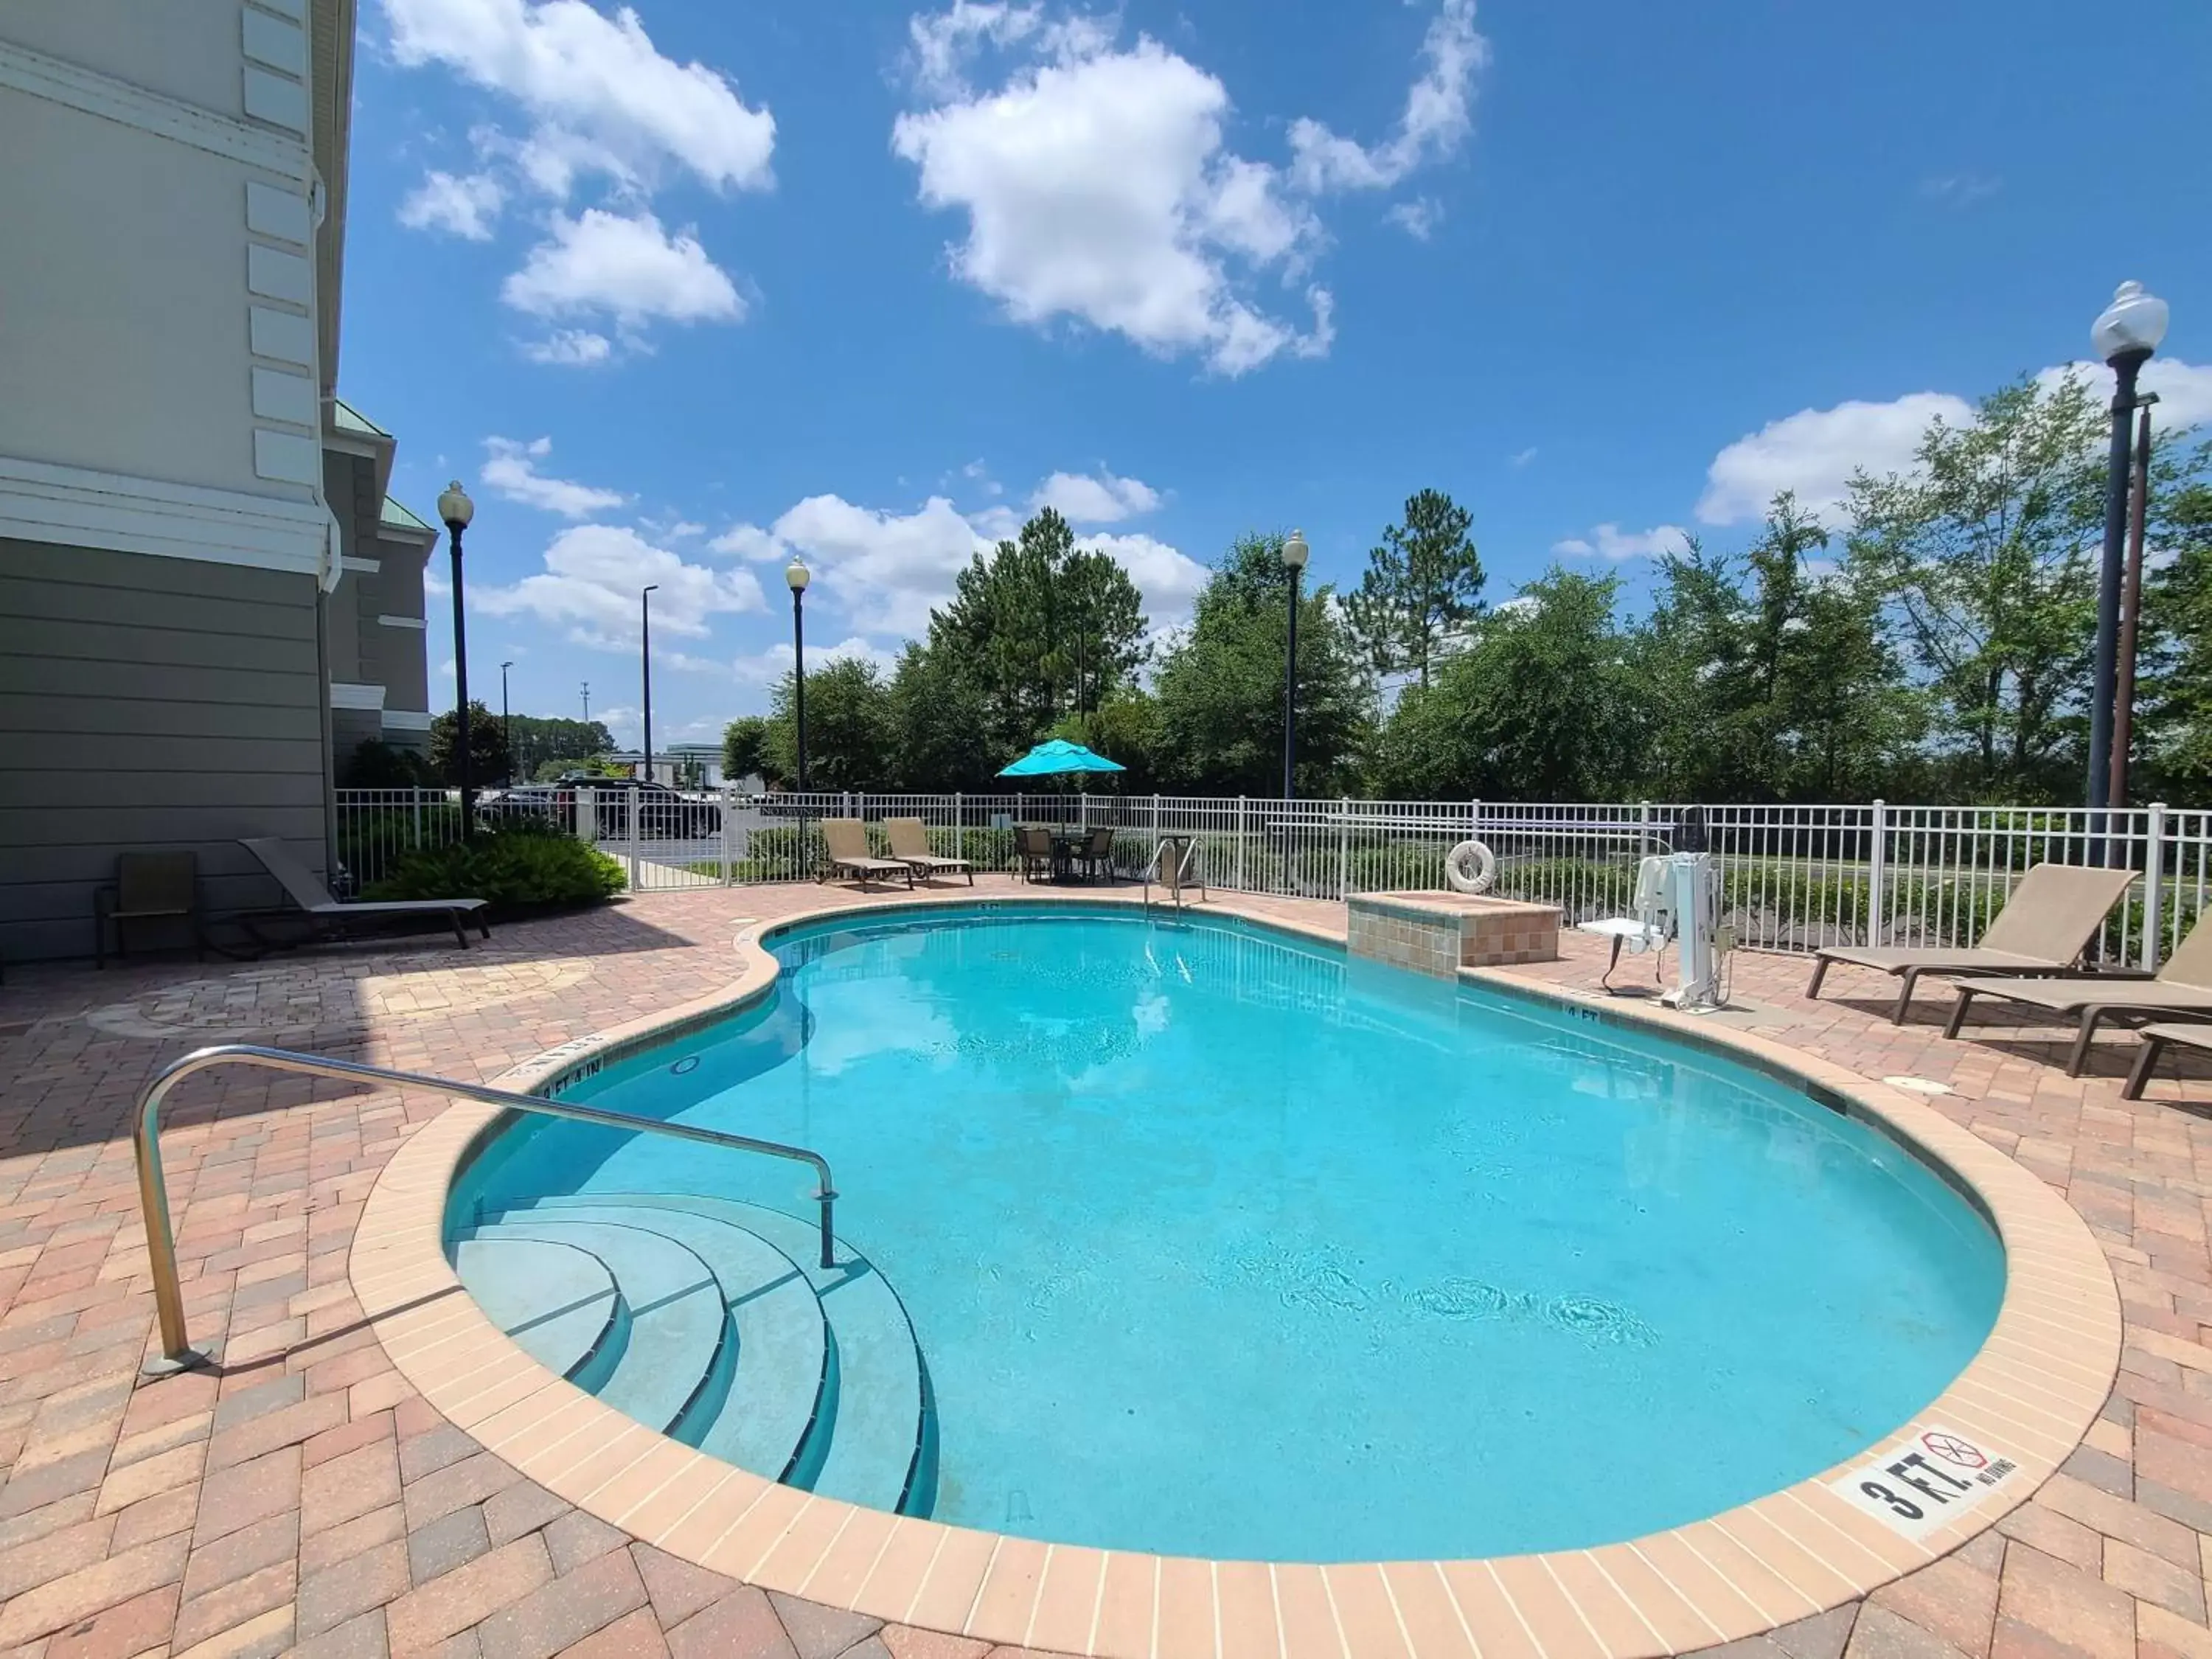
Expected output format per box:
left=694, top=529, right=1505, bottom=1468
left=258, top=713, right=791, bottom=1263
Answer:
left=0, top=878, right=2212, bottom=1659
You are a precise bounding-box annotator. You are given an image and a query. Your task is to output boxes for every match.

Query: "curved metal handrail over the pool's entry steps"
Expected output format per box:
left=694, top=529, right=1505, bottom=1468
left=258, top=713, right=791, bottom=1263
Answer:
left=135, top=1042, right=836, bottom=1376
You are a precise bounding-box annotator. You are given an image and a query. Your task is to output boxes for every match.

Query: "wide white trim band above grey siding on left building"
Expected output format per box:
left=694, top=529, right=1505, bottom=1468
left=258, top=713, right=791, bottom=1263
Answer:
left=0, top=456, right=330, bottom=575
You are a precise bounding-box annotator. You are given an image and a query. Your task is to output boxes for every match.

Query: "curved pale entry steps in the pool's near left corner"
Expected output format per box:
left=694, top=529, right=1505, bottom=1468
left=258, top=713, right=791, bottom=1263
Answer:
left=453, top=1192, right=936, bottom=1515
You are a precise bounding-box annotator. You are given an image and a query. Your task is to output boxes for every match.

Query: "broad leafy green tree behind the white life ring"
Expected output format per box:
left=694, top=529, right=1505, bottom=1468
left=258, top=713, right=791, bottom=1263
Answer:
left=1376, top=566, right=1639, bottom=801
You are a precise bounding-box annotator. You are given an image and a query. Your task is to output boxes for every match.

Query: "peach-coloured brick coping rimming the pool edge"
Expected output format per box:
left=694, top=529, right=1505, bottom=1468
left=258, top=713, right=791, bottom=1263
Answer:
left=349, top=887, right=2121, bottom=1659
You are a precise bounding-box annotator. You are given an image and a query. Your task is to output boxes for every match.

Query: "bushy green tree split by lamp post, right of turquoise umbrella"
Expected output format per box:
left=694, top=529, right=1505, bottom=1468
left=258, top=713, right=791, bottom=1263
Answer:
left=1152, top=535, right=1374, bottom=794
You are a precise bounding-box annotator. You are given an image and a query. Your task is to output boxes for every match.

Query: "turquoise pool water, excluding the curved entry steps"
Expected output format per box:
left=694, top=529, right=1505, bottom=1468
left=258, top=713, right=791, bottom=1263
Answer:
left=462, top=907, right=2004, bottom=1559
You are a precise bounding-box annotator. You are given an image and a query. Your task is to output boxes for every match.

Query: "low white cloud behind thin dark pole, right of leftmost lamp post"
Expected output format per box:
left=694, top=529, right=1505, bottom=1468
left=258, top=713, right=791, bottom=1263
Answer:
left=469, top=524, right=768, bottom=650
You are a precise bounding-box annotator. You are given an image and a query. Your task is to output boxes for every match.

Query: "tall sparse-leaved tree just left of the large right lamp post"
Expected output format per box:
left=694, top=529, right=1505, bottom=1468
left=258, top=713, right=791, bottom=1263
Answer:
left=1849, top=372, right=2106, bottom=801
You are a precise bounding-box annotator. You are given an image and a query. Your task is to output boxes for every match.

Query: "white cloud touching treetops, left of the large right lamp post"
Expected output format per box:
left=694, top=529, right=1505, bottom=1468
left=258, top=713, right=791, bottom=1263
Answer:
left=1697, top=392, right=1973, bottom=526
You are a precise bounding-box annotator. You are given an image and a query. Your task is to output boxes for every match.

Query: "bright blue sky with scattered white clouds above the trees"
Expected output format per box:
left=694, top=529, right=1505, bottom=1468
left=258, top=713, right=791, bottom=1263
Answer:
left=341, top=0, right=2212, bottom=743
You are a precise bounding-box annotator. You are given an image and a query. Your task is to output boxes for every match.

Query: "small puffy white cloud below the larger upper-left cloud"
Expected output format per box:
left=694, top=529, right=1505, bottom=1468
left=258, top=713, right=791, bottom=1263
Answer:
left=500, top=208, right=745, bottom=330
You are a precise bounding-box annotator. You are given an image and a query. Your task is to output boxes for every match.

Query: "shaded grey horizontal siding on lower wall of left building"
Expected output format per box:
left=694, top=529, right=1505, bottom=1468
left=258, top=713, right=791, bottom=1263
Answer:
left=0, top=540, right=327, bottom=960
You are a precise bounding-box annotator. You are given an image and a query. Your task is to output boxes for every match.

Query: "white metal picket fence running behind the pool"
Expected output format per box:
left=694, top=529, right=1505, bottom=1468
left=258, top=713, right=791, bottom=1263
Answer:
left=338, top=787, right=2212, bottom=967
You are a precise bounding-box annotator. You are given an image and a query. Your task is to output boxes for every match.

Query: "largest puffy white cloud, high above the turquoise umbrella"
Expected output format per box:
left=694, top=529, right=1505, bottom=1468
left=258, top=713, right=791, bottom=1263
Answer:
left=891, top=24, right=1329, bottom=374
